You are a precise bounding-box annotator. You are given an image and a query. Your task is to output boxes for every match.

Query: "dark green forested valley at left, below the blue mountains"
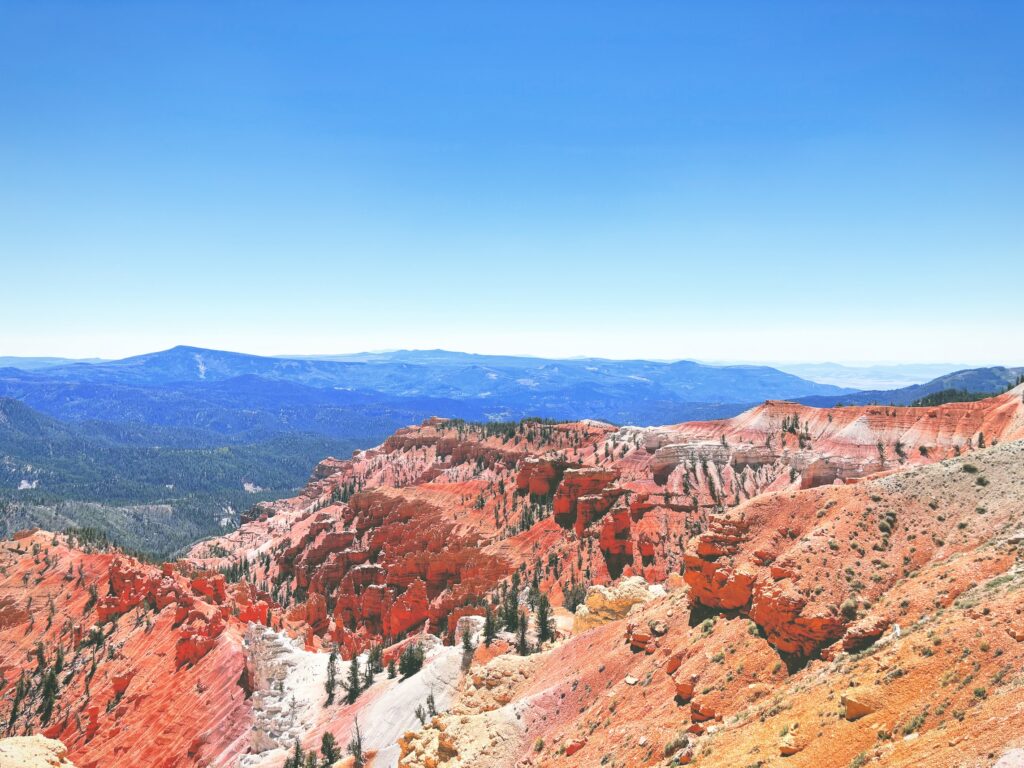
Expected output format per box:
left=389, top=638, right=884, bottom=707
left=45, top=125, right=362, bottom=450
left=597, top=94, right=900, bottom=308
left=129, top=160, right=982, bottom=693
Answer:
left=0, top=398, right=355, bottom=554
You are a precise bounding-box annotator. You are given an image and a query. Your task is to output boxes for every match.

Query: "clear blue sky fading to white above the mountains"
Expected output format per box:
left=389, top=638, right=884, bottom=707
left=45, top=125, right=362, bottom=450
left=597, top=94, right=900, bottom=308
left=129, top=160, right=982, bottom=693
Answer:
left=0, top=0, right=1024, bottom=364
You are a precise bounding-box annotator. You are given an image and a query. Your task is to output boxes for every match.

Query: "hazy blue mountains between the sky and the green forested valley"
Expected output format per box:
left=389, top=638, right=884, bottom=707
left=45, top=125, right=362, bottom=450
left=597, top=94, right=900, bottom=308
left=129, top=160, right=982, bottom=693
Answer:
left=0, top=346, right=853, bottom=436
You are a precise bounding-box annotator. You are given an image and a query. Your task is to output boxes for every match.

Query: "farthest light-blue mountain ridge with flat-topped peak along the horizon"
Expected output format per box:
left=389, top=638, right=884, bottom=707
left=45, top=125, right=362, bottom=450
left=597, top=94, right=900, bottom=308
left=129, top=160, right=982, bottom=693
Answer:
left=12, top=346, right=841, bottom=402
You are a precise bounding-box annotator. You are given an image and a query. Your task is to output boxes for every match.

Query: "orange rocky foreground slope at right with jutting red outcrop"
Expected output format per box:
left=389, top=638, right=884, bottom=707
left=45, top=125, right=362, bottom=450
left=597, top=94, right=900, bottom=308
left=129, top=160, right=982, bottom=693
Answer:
left=462, top=442, right=1024, bottom=768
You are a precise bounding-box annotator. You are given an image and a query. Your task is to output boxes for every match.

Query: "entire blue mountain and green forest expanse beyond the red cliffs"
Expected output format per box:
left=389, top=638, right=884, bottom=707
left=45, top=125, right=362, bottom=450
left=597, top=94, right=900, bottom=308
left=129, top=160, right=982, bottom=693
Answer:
left=0, top=346, right=1019, bottom=554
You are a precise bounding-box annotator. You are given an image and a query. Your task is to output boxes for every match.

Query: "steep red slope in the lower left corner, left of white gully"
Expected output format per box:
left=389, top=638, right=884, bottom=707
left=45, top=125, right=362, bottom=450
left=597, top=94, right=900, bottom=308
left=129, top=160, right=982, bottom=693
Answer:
left=0, top=531, right=248, bottom=768
